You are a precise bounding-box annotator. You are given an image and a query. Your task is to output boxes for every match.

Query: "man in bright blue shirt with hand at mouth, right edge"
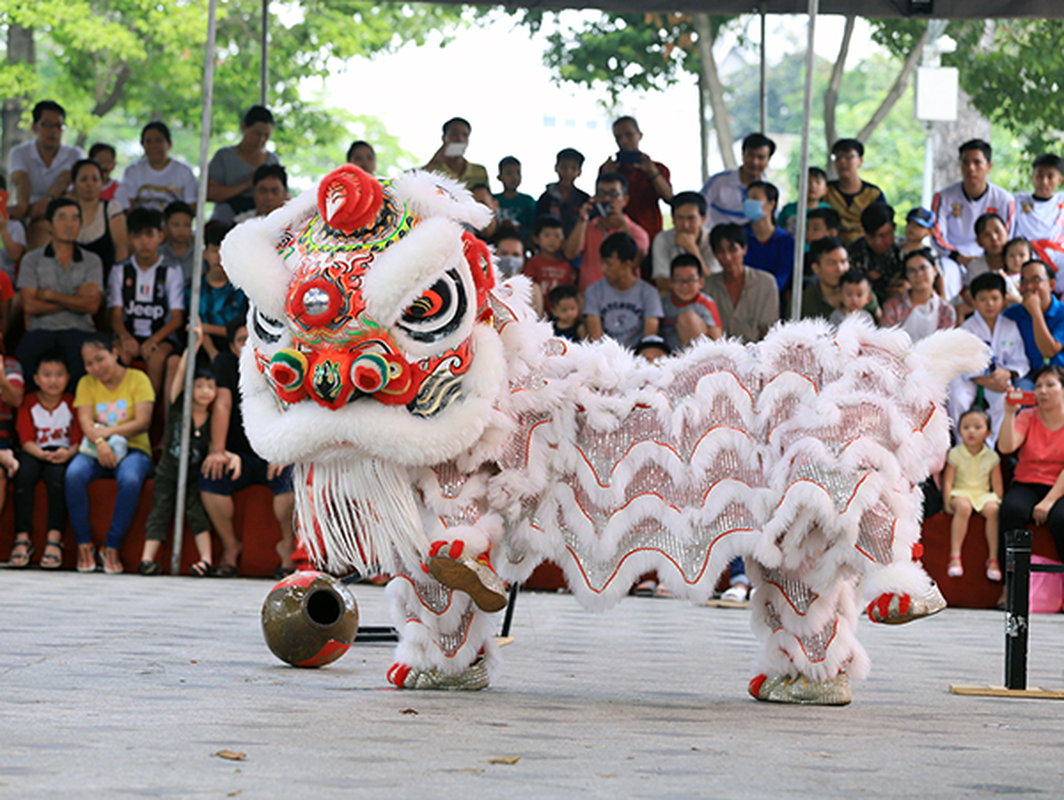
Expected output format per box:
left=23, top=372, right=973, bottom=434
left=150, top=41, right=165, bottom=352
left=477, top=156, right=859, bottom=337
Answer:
left=1002, top=261, right=1064, bottom=380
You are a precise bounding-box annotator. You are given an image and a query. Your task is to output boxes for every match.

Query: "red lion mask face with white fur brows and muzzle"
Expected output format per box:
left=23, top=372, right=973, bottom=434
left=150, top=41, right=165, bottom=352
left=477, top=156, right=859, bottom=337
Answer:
left=222, top=165, right=514, bottom=468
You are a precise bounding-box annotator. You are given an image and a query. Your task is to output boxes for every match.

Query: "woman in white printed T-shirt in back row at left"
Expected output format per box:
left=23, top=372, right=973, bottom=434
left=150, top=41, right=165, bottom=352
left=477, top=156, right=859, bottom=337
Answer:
left=115, top=120, right=198, bottom=211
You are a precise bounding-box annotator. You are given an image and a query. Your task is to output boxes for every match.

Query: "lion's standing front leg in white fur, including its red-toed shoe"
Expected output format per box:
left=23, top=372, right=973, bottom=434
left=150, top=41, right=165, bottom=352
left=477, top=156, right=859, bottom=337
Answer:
left=386, top=574, right=499, bottom=689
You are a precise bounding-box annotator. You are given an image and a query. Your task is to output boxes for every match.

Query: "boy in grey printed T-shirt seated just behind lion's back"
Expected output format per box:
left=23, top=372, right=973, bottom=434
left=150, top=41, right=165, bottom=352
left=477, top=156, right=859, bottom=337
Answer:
left=584, top=233, right=662, bottom=349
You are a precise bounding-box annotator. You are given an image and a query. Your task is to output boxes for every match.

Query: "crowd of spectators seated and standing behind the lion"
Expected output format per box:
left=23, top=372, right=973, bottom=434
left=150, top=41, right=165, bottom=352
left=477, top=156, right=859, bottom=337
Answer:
left=0, top=96, right=1064, bottom=599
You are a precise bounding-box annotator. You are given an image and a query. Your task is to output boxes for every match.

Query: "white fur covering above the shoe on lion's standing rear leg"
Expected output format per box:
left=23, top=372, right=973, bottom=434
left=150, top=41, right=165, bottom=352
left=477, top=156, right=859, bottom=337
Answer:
left=746, top=559, right=868, bottom=681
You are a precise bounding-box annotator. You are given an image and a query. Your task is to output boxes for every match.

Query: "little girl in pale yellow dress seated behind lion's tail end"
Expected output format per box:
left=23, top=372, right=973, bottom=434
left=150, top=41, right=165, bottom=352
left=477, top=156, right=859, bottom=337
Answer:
left=942, top=409, right=1003, bottom=581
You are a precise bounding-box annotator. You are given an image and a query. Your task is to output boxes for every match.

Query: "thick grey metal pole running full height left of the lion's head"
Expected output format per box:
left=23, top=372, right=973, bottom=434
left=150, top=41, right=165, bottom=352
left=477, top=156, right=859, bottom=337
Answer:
left=170, top=0, right=218, bottom=574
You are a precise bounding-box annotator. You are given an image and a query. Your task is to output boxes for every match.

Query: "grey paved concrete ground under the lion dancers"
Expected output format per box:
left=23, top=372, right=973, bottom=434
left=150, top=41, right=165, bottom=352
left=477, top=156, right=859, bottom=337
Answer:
left=0, top=570, right=1064, bottom=800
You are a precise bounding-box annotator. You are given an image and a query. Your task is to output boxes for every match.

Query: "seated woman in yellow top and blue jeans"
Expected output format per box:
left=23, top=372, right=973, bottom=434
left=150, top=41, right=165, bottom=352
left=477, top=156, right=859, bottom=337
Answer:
left=66, top=333, right=155, bottom=574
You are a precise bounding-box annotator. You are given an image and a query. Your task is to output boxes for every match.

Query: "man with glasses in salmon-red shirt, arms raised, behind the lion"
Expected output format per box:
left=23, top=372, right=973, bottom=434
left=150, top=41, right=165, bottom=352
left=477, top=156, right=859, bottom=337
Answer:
left=562, top=172, right=650, bottom=295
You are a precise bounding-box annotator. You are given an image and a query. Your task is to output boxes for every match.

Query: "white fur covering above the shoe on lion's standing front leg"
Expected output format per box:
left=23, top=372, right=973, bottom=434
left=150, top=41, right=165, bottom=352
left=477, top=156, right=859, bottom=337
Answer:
left=386, top=574, right=501, bottom=679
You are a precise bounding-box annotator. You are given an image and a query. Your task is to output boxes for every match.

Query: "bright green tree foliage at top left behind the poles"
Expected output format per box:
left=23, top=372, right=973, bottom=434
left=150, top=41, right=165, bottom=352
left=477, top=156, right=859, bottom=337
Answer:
left=0, top=0, right=470, bottom=174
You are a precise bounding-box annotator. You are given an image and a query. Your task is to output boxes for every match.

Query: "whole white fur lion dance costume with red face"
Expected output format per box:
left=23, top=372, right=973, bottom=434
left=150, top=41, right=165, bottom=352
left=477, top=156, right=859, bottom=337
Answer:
left=222, top=165, right=986, bottom=703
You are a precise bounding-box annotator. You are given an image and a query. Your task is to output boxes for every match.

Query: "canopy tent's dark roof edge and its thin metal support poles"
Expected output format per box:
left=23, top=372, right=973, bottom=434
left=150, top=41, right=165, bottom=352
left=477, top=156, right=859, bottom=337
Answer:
left=170, top=0, right=1064, bottom=574
